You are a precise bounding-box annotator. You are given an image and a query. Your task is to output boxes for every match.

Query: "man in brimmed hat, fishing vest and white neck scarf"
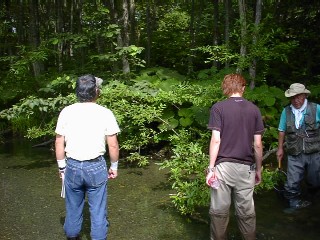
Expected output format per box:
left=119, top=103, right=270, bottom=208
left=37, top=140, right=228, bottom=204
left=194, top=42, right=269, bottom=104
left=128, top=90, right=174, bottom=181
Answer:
left=277, top=83, right=320, bottom=209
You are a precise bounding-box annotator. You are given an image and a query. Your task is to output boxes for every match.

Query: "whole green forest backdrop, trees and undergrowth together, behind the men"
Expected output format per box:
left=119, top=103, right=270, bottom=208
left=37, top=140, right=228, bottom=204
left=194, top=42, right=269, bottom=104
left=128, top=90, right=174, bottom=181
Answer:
left=0, top=0, right=320, bottom=214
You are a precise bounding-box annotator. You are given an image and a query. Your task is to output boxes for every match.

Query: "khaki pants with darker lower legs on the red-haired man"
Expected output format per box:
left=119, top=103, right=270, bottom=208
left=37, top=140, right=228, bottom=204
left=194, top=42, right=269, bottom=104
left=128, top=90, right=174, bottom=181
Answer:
left=209, top=162, right=256, bottom=240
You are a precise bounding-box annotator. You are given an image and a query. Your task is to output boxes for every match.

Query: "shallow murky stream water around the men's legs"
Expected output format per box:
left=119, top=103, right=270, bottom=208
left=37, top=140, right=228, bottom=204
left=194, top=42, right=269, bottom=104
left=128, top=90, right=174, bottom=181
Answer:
left=0, top=138, right=320, bottom=240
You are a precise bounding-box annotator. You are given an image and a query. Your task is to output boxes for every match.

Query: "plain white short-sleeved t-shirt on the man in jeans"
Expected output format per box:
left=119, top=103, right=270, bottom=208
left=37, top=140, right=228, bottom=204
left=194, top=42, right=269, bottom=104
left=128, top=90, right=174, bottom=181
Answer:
left=55, top=103, right=120, bottom=161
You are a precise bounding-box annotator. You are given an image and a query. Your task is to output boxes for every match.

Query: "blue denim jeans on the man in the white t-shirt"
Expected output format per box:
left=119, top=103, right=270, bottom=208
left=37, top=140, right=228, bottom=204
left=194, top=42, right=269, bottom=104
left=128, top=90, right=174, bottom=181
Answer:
left=64, top=156, right=109, bottom=240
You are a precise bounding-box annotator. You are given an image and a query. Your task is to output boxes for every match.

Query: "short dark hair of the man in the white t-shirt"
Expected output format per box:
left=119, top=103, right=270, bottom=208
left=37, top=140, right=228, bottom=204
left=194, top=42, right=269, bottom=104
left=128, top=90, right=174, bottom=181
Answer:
left=76, top=74, right=98, bottom=102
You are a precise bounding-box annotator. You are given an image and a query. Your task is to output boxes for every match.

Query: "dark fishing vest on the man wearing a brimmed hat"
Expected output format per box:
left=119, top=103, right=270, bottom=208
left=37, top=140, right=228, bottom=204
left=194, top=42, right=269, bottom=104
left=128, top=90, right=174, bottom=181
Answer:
left=285, top=103, right=320, bottom=155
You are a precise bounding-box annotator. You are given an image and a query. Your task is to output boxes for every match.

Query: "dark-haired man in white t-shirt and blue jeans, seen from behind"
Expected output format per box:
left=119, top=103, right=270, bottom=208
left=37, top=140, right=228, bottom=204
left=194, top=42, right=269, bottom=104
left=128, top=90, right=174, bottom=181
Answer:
left=55, top=75, right=120, bottom=240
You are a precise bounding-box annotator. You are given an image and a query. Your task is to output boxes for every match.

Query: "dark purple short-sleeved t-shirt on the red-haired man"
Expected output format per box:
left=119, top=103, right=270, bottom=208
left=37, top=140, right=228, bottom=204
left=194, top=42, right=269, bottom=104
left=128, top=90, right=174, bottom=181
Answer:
left=208, top=97, right=264, bottom=165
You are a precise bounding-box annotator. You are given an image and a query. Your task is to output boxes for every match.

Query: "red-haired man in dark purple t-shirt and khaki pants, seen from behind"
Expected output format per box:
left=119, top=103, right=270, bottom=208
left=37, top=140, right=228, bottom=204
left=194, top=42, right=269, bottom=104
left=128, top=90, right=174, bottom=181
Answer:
left=206, top=74, right=264, bottom=240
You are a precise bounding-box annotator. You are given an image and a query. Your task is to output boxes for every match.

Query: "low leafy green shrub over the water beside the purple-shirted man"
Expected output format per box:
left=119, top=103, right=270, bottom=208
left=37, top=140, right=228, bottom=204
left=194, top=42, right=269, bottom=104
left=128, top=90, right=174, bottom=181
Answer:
left=160, top=130, right=210, bottom=214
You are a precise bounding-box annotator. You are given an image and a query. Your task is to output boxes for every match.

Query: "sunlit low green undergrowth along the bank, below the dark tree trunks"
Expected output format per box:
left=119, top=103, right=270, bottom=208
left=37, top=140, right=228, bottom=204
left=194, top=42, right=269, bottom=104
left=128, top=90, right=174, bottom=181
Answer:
left=0, top=68, right=287, bottom=214
